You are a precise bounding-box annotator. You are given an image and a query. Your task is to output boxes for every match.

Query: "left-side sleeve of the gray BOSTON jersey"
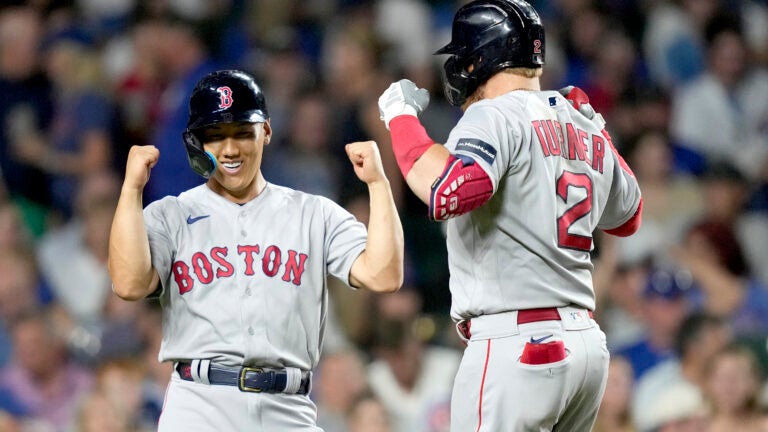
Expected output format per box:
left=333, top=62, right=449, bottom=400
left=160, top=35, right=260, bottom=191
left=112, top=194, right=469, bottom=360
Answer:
left=144, top=197, right=175, bottom=297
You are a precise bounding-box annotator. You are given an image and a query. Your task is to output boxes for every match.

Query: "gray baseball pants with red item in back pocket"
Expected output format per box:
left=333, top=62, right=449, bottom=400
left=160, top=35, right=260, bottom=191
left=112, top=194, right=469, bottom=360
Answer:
left=451, top=321, right=607, bottom=432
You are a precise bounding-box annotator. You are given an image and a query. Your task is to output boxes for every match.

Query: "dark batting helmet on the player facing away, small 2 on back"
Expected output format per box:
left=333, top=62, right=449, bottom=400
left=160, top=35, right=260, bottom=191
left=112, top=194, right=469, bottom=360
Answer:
left=435, top=0, right=544, bottom=106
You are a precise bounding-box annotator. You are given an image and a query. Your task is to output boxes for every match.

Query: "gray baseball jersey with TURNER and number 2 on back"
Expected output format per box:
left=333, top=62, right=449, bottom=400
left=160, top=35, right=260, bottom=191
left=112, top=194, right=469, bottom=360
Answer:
left=446, top=91, right=640, bottom=320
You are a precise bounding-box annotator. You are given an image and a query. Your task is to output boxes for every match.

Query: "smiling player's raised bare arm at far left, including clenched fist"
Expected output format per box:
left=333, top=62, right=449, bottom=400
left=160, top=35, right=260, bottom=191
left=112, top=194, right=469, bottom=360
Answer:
left=107, top=146, right=160, bottom=300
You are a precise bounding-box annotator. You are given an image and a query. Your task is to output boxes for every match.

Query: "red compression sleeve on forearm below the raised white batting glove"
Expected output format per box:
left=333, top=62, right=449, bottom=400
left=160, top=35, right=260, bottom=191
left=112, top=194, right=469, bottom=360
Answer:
left=389, top=115, right=435, bottom=178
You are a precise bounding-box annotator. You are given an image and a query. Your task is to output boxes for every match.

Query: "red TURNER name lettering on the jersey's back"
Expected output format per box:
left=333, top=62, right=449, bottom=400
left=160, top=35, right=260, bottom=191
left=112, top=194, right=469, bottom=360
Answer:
left=531, top=120, right=605, bottom=174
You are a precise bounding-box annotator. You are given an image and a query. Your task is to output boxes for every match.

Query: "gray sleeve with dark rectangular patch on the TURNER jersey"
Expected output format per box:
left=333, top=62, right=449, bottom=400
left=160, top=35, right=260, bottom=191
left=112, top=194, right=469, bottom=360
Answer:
left=445, top=102, right=519, bottom=192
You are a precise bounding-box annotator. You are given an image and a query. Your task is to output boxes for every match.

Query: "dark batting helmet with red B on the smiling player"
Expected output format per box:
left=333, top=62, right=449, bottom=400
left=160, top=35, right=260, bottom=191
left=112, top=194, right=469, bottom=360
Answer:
left=182, top=70, right=269, bottom=178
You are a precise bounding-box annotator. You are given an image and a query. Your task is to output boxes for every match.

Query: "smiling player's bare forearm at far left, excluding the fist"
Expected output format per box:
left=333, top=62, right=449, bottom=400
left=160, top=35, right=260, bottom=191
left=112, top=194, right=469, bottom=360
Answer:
left=108, top=188, right=157, bottom=300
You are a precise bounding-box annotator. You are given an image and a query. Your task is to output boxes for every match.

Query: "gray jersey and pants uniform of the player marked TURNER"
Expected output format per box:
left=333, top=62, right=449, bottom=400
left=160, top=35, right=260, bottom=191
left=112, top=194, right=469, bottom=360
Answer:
left=446, top=91, right=640, bottom=431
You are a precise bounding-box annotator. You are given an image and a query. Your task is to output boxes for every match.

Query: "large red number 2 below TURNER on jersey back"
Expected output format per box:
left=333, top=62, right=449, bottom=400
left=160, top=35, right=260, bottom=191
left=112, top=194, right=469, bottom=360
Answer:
left=557, top=171, right=592, bottom=252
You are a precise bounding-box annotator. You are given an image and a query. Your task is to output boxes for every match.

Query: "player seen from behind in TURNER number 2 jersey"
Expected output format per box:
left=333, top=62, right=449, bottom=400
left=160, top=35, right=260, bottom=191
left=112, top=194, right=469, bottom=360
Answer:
left=379, top=0, right=641, bottom=432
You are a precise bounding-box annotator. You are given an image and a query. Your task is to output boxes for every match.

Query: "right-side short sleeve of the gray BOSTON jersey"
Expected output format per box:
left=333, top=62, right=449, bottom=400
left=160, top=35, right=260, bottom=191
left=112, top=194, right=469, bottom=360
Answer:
left=321, top=198, right=368, bottom=286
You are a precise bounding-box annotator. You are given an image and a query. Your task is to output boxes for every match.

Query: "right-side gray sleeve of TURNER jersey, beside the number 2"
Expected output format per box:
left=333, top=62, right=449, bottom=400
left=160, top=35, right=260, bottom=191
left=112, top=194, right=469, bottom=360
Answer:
left=597, top=146, right=641, bottom=230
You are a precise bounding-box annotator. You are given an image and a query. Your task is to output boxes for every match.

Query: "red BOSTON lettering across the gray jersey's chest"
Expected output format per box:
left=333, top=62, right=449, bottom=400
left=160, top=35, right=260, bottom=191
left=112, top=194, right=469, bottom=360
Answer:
left=172, top=245, right=307, bottom=294
